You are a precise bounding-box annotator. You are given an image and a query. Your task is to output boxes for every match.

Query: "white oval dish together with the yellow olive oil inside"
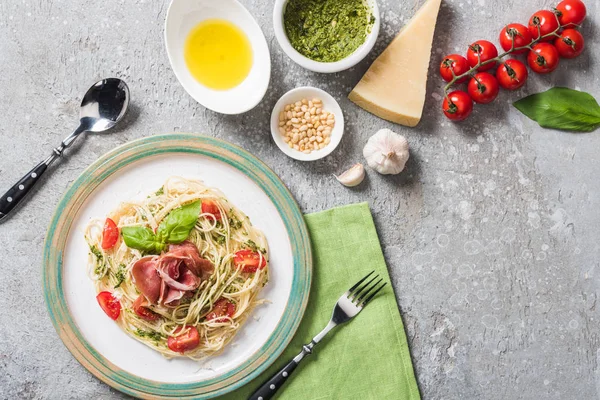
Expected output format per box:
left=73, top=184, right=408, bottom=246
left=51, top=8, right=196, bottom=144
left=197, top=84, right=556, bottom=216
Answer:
left=165, top=0, right=271, bottom=114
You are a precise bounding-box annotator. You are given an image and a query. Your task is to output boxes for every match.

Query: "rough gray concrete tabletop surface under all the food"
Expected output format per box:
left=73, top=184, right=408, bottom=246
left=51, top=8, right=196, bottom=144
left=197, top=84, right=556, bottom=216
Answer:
left=0, top=0, right=600, bottom=399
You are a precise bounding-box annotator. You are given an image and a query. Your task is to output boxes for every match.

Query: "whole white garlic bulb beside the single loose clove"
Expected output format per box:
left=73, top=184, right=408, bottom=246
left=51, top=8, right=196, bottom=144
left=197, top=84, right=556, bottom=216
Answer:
left=363, top=129, right=409, bottom=175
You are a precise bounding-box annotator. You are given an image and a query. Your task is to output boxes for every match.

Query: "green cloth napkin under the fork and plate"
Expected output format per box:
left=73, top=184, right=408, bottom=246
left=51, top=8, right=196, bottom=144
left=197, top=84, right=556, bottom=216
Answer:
left=223, top=203, right=420, bottom=400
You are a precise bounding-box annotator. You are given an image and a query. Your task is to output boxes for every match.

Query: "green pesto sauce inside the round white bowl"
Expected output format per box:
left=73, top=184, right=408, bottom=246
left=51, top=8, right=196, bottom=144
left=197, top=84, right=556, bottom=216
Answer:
left=283, top=0, right=375, bottom=62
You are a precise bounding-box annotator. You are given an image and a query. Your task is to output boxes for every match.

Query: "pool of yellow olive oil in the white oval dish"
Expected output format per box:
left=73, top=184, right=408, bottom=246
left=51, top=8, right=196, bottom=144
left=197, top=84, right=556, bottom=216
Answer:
left=184, top=19, right=253, bottom=90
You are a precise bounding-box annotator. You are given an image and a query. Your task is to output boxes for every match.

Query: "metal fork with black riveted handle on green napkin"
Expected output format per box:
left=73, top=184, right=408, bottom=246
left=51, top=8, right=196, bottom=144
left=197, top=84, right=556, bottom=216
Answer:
left=248, top=271, right=386, bottom=400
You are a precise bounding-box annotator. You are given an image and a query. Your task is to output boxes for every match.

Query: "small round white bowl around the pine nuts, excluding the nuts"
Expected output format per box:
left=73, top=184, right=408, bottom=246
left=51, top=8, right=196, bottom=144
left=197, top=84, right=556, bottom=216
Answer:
left=271, top=86, right=344, bottom=161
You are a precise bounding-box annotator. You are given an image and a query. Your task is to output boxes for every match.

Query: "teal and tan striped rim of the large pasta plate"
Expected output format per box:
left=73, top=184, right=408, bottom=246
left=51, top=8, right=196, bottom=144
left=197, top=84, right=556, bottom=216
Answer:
left=42, top=133, right=313, bottom=399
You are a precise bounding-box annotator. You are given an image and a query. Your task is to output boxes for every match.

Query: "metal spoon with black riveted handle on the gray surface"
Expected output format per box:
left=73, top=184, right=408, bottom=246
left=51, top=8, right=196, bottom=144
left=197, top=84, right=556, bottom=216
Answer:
left=0, top=78, right=129, bottom=221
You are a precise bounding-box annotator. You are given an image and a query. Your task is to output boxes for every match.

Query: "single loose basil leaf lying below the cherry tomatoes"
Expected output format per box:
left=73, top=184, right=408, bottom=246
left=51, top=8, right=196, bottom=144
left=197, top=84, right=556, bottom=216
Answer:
left=513, top=87, right=600, bottom=132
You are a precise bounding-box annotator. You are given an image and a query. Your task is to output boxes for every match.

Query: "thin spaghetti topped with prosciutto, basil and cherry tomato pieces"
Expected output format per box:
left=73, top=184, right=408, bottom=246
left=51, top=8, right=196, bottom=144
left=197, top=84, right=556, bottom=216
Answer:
left=85, top=177, right=269, bottom=359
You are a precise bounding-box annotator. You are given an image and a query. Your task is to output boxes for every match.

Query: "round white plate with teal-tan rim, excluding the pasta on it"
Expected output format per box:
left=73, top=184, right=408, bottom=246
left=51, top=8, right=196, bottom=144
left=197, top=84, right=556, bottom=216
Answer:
left=45, top=135, right=312, bottom=397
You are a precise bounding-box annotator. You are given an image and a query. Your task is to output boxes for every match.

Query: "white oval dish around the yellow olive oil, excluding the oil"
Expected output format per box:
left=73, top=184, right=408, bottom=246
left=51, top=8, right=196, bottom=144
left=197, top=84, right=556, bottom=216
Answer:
left=165, top=0, right=271, bottom=114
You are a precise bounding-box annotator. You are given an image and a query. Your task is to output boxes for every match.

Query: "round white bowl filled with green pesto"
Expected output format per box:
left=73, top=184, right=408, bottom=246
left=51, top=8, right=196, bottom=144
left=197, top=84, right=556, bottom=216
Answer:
left=273, top=0, right=380, bottom=73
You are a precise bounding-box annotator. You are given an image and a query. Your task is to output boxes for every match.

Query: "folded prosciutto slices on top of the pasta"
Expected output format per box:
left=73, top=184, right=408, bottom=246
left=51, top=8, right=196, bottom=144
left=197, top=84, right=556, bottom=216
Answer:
left=131, top=241, right=214, bottom=307
